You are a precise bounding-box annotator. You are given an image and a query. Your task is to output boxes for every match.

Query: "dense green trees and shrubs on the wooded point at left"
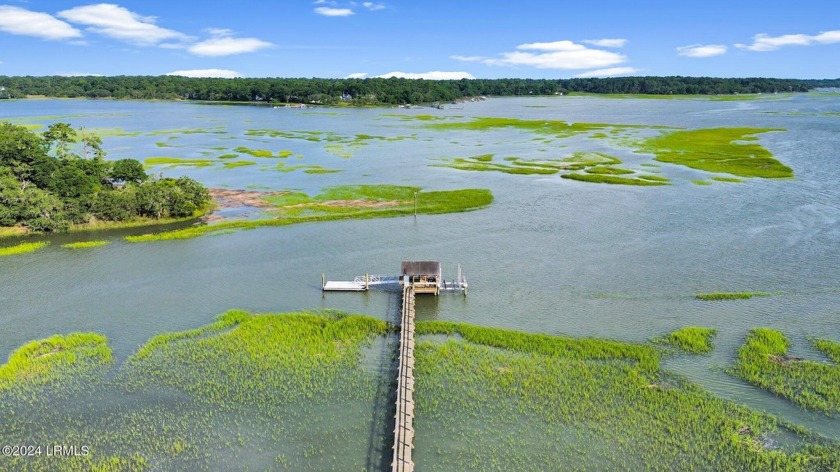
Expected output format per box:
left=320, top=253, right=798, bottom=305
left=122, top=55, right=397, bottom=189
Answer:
left=0, top=123, right=210, bottom=231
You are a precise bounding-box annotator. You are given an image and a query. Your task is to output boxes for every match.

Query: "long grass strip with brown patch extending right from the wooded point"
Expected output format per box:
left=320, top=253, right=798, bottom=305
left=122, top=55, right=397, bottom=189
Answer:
left=125, top=185, right=493, bottom=242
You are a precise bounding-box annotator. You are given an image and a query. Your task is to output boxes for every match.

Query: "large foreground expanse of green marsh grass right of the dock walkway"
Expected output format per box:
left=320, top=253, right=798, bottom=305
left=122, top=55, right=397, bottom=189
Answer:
left=413, top=321, right=840, bottom=471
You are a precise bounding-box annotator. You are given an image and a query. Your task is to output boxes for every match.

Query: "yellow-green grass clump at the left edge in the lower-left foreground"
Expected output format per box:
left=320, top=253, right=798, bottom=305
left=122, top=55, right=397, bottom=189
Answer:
left=0, top=333, right=112, bottom=392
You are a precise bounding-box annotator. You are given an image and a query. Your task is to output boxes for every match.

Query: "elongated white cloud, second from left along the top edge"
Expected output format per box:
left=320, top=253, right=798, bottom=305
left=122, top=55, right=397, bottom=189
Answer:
left=58, top=3, right=189, bottom=46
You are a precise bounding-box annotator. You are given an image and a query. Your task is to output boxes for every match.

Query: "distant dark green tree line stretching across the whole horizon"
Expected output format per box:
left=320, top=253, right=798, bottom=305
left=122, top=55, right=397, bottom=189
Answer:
left=0, top=76, right=840, bottom=105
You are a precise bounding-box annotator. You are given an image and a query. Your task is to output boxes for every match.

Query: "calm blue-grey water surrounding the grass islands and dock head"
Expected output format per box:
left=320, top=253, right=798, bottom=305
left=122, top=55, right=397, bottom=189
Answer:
left=0, top=94, right=840, bottom=460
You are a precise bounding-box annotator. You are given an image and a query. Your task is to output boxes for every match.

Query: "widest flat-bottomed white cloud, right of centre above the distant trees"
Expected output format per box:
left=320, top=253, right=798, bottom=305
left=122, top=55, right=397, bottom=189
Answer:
left=450, top=41, right=627, bottom=69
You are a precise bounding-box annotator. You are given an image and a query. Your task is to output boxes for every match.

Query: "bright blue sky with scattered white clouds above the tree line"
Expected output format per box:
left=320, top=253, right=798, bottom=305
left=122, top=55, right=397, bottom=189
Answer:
left=0, top=0, right=840, bottom=79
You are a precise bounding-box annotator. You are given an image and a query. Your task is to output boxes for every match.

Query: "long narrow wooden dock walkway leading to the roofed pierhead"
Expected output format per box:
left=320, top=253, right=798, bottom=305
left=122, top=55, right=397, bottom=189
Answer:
left=391, top=284, right=414, bottom=472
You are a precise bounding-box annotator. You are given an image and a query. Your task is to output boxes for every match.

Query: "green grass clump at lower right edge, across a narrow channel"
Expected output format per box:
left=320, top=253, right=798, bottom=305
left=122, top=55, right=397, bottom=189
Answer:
left=728, top=328, right=840, bottom=415
